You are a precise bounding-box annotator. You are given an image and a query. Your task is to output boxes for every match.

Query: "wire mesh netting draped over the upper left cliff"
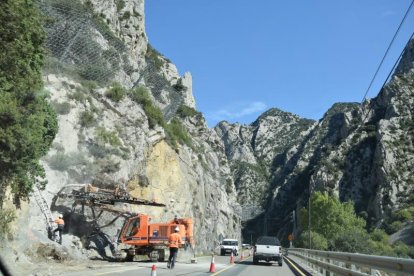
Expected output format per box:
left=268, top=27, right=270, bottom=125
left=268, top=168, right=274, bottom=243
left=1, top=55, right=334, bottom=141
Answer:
left=38, top=0, right=138, bottom=85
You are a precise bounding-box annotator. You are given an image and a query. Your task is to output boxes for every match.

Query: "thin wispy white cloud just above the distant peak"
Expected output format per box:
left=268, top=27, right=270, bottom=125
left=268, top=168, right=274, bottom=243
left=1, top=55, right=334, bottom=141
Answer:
left=207, top=102, right=267, bottom=121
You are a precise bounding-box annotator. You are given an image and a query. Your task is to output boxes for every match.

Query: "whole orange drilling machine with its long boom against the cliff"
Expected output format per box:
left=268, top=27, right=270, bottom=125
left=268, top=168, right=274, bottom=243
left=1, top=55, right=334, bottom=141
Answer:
left=54, top=184, right=194, bottom=261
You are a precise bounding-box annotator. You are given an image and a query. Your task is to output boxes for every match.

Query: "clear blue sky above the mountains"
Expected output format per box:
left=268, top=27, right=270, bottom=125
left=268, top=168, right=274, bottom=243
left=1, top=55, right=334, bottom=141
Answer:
left=145, top=0, right=414, bottom=127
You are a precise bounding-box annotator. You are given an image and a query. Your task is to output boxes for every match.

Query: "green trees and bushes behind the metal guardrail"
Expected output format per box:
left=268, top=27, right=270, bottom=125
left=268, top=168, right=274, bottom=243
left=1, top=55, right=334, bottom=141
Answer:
left=295, top=192, right=414, bottom=258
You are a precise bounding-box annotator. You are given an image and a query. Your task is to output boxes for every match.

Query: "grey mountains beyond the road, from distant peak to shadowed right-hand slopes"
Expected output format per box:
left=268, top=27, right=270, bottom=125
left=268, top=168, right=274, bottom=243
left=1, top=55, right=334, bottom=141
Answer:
left=215, top=38, right=414, bottom=242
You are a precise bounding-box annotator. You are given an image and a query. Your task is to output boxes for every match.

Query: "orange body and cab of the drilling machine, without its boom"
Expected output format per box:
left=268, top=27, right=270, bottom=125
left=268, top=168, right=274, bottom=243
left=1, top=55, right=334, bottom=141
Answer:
left=118, top=214, right=194, bottom=260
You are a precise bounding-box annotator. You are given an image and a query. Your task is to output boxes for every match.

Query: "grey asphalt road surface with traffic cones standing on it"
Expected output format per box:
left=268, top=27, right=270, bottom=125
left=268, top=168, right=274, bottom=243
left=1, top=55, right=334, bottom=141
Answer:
left=63, top=254, right=295, bottom=276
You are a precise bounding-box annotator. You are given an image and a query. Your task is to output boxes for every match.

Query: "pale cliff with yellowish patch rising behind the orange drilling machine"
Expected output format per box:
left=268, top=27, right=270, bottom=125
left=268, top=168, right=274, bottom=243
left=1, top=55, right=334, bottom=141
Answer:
left=1, top=0, right=241, bottom=268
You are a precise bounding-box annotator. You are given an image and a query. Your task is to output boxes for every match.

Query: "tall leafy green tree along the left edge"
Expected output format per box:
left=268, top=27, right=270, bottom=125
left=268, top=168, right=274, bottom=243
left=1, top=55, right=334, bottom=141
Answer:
left=0, top=0, right=57, bottom=234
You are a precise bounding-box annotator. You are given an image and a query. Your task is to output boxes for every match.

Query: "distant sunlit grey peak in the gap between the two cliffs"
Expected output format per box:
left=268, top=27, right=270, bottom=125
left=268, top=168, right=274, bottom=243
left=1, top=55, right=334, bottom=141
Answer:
left=214, top=108, right=315, bottom=208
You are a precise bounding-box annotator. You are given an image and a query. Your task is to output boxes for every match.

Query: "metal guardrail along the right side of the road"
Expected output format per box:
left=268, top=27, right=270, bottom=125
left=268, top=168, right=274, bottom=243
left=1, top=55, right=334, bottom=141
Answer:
left=287, top=248, right=414, bottom=275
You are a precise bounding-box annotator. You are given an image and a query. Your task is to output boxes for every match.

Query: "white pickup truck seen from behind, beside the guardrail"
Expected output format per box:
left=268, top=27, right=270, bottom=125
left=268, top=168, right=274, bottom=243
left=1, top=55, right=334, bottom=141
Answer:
left=253, top=236, right=283, bottom=266
